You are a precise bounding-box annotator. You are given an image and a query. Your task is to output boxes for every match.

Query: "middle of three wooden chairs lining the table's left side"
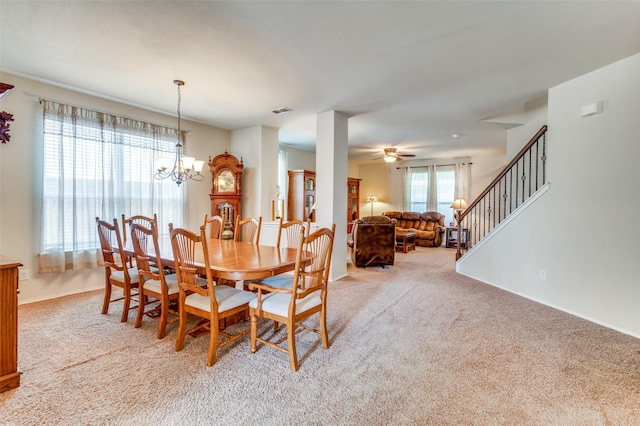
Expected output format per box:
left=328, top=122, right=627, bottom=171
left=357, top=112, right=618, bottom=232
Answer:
left=131, top=223, right=178, bottom=339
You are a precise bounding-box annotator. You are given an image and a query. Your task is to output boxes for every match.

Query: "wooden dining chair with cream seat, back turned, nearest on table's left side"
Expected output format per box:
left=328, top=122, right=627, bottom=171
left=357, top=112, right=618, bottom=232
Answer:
left=171, top=225, right=256, bottom=367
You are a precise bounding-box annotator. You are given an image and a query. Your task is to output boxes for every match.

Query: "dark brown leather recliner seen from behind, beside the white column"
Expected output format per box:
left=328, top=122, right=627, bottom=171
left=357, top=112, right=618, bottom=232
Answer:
left=347, top=216, right=396, bottom=267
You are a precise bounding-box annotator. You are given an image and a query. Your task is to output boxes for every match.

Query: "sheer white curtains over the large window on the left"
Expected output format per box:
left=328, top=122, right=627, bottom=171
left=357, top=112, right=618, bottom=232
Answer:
left=39, top=101, right=185, bottom=273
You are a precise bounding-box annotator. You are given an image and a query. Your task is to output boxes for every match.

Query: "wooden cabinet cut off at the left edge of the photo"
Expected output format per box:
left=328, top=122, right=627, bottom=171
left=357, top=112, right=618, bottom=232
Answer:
left=0, top=254, right=22, bottom=392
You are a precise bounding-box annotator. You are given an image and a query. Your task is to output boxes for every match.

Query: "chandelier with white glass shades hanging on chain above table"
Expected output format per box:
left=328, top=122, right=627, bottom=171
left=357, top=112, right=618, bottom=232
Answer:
left=153, top=80, right=204, bottom=186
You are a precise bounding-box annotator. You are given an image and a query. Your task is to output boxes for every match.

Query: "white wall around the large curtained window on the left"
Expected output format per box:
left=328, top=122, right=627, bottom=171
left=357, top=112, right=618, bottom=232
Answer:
left=0, top=73, right=229, bottom=303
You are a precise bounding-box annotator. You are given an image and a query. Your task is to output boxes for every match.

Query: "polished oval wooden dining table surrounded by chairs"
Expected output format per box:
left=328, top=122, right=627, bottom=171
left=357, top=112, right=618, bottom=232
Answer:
left=124, top=235, right=311, bottom=288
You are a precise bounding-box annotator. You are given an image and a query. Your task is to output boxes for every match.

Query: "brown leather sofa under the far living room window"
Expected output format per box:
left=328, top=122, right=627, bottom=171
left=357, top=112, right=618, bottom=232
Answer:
left=382, top=212, right=445, bottom=247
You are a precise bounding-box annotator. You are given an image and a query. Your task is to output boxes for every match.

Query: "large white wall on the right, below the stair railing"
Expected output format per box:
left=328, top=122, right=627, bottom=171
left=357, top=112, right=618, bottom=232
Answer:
left=458, top=54, right=640, bottom=337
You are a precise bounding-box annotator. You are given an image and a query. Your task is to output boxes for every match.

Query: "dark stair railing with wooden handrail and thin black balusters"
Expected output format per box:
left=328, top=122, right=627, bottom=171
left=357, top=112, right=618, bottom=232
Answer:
left=456, top=126, right=547, bottom=260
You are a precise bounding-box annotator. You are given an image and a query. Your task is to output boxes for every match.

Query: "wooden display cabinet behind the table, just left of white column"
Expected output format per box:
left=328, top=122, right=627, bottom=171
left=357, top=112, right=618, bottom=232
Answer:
left=287, top=170, right=316, bottom=222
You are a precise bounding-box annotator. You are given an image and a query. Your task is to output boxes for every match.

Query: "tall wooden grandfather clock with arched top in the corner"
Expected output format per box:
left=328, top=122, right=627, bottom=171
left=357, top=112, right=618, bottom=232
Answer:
left=209, top=150, right=244, bottom=240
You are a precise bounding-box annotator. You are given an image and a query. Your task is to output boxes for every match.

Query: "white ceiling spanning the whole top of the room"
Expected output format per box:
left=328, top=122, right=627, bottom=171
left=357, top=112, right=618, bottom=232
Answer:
left=0, top=0, right=640, bottom=161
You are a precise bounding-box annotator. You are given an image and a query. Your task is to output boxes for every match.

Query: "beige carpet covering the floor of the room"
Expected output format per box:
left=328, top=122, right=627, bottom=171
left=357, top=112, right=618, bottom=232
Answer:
left=0, top=247, right=640, bottom=425
